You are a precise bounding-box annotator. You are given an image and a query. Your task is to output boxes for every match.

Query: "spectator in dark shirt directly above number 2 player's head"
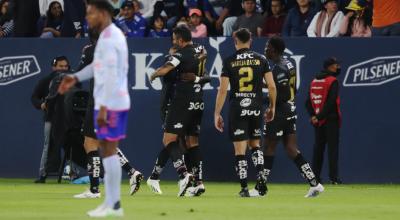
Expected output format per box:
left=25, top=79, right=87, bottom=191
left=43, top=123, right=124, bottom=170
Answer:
left=233, top=0, right=264, bottom=37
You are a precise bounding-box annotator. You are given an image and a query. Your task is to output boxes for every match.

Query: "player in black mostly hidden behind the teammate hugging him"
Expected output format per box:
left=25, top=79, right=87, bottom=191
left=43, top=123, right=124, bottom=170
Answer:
left=147, top=44, right=210, bottom=196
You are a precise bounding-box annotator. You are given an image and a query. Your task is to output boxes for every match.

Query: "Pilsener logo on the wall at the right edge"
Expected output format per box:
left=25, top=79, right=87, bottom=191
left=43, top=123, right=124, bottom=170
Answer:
left=343, top=56, right=400, bottom=87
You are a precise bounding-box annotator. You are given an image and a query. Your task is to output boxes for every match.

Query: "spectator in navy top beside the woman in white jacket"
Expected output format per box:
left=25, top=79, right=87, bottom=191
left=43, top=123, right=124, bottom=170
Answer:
left=282, top=0, right=317, bottom=37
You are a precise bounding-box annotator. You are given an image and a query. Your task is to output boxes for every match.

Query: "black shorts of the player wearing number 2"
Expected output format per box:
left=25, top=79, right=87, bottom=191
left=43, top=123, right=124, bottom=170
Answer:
left=229, top=106, right=263, bottom=142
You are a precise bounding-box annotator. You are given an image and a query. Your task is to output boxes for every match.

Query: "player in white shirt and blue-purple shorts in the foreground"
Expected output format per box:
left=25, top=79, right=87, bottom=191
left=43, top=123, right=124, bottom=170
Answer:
left=59, top=0, right=130, bottom=217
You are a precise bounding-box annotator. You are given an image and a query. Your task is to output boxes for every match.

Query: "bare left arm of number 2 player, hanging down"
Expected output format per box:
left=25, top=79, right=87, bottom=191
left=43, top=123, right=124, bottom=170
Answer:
left=214, top=76, right=229, bottom=132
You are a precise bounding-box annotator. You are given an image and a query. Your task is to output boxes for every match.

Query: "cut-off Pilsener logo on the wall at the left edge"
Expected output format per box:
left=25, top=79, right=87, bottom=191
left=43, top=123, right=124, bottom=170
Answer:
left=0, top=55, right=40, bottom=86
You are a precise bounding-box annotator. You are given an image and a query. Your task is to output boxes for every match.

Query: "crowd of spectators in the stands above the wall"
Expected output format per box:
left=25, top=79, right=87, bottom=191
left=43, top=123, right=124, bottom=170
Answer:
left=0, top=0, right=400, bottom=38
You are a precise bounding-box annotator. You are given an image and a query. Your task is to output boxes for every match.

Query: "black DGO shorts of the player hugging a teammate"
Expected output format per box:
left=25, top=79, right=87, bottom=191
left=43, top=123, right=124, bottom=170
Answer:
left=164, top=100, right=204, bottom=136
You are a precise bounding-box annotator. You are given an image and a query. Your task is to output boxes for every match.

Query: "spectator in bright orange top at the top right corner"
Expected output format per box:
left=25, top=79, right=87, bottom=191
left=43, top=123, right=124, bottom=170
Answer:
left=370, top=0, right=400, bottom=36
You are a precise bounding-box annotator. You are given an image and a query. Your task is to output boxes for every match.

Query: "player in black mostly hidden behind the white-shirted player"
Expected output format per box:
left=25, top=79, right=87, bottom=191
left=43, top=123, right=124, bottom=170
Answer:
left=74, top=30, right=143, bottom=199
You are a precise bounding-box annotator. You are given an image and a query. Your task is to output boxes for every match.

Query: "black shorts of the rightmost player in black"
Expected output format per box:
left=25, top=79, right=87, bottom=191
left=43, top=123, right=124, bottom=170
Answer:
left=263, top=116, right=296, bottom=140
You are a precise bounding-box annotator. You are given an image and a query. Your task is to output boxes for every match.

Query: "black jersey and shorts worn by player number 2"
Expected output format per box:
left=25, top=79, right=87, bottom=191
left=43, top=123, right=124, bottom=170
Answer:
left=221, top=49, right=270, bottom=142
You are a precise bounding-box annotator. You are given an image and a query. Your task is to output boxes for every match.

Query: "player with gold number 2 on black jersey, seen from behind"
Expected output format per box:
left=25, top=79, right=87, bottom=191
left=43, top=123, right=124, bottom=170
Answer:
left=214, top=28, right=276, bottom=197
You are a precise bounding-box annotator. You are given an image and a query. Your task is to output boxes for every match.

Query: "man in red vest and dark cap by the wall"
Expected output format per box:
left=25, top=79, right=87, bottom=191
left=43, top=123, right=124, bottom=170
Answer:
left=306, top=57, right=342, bottom=184
